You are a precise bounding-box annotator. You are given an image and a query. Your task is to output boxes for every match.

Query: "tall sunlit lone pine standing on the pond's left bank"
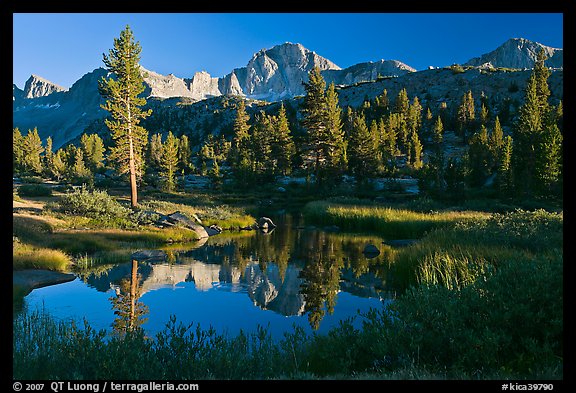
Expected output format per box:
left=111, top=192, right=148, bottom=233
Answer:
left=99, top=26, right=152, bottom=207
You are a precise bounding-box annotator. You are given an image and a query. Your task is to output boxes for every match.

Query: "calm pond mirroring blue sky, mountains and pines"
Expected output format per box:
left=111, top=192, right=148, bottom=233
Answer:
left=25, top=215, right=395, bottom=338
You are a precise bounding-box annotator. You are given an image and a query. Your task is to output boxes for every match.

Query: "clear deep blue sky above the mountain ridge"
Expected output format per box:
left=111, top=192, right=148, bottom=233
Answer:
left=13, top=13, right=563, bottom=88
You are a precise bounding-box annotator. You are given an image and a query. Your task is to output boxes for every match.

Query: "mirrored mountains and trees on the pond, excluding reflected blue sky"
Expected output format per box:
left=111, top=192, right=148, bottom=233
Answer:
left=74, top=216, right=394, bottom=334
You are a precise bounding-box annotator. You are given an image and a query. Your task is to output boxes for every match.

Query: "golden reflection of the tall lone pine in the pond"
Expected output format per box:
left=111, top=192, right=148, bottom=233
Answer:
left=110, top=260, right=149, bottom=336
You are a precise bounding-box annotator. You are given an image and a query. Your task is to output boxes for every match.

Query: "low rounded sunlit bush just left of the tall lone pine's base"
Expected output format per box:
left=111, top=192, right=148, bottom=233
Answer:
left=56, top=187, right=131, bottom=219
